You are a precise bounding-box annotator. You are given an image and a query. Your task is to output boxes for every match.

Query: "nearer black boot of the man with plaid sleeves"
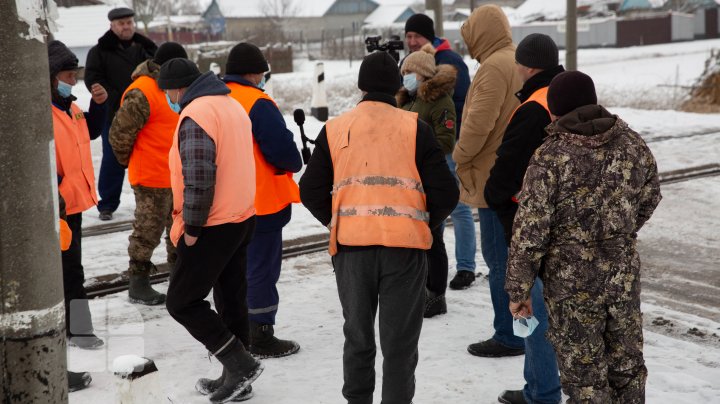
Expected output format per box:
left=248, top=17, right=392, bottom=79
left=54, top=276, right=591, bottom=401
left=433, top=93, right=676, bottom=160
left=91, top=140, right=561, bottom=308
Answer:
left=210, top=340, right=263, bottom=403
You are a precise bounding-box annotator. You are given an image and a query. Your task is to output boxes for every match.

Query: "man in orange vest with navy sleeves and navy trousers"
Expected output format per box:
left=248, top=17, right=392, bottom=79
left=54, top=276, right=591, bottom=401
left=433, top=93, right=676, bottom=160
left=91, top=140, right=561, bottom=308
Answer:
left=224, top=43, right=302, bottom=358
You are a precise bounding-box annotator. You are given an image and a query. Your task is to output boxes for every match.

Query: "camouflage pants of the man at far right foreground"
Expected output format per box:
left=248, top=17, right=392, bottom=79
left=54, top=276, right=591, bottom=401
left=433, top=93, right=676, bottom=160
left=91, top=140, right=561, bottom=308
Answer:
left=545, top=288, right=647, bottom=404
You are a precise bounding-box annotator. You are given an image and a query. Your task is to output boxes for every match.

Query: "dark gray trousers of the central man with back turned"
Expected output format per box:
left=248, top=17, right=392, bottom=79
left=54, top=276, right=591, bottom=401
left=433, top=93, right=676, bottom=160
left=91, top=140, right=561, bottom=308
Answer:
left=333, top=247, right=427, bottom=404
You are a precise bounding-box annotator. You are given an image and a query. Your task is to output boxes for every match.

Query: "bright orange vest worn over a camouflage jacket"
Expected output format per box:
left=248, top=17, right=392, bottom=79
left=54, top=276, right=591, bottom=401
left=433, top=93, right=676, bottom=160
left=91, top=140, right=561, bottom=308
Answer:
left=120, top=76, right=180, bottom=188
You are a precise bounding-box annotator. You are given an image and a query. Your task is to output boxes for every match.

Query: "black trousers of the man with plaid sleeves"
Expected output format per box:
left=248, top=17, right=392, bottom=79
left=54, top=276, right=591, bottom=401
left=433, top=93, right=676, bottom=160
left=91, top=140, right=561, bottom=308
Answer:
left=165, top=216, right=255, bottom=353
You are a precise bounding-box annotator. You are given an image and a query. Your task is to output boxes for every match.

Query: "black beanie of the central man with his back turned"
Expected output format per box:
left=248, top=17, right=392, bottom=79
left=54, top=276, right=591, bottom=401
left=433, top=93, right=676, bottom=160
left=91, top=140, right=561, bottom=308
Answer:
left=358, top=52, right=402, bottom=96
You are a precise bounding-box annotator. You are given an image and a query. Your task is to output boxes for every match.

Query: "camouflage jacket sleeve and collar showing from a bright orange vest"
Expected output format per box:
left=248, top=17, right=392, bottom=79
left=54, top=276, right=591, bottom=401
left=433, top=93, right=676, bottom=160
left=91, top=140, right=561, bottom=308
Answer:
left=108, top=60, right=160, bottom=167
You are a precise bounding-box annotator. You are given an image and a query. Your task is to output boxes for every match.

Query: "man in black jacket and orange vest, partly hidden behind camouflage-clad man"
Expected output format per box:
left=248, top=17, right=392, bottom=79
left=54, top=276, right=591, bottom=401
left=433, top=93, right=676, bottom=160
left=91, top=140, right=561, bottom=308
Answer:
left=484, top=34, right=565, bottom=404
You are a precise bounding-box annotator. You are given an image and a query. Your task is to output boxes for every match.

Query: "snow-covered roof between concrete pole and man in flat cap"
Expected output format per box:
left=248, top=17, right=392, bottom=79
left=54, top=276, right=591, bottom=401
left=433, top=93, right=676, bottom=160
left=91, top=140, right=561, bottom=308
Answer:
left=53, top=5, right=113, bottom=48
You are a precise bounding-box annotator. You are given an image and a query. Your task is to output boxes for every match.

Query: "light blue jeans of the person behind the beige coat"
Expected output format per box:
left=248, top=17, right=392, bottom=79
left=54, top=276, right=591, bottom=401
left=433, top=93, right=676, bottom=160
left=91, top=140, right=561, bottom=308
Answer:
left=445, top=154, right=477, bottom=273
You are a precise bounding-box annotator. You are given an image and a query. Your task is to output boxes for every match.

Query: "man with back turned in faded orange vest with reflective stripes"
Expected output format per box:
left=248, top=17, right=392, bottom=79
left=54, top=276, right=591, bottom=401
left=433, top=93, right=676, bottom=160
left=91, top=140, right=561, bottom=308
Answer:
left=300, top=52, right=459, bottom=404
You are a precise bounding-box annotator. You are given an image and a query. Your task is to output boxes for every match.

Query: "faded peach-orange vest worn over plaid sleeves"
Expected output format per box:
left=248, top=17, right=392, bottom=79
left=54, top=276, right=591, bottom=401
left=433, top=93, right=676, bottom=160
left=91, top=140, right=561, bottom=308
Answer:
left=169, top=95, right=255, bottom=245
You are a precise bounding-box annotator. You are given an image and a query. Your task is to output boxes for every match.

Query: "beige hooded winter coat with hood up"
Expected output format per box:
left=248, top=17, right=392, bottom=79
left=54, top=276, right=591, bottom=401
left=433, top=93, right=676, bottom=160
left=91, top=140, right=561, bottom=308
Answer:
left=453, top=5, right=522, bottom=208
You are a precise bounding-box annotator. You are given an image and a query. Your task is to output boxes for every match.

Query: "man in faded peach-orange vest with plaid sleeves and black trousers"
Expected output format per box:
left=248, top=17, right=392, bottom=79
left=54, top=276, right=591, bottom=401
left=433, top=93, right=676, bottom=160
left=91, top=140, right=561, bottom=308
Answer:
left=158, top=58, right=263, bottom=403
